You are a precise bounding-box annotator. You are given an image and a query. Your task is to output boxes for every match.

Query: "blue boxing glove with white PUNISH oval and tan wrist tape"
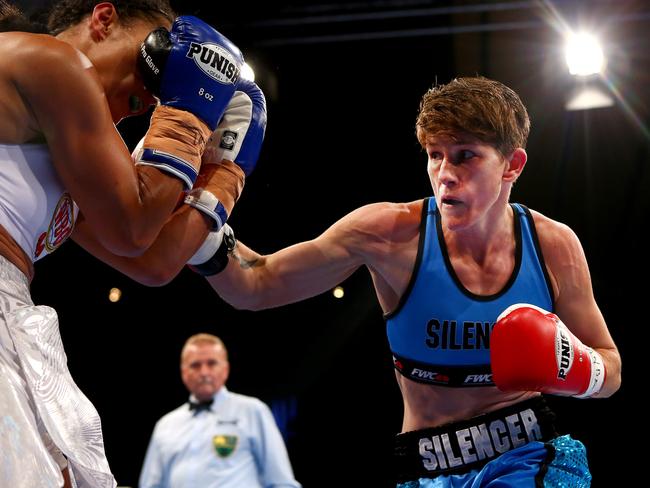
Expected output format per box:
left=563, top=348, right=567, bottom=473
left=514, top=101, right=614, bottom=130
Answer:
left=137, top=16, right=244, bottom=190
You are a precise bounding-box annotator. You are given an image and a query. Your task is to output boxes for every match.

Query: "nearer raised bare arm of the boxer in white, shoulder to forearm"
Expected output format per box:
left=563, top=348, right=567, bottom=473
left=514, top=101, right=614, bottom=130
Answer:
left=13, top=34, right=182, bottom=255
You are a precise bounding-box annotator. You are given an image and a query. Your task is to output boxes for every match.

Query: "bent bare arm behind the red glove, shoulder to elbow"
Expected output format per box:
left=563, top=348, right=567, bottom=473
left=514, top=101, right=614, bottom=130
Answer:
left=535, top=213, right=621, bottom=397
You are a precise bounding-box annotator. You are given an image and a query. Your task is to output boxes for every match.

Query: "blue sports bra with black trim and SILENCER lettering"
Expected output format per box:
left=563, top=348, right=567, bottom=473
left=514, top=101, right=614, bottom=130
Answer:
left=385, top=198, right=553, bottom=387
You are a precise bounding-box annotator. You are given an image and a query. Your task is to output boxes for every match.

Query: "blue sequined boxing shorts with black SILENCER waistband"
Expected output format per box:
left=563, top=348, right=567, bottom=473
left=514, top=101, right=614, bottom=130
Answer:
left=394, top=397, right=591, bottom=488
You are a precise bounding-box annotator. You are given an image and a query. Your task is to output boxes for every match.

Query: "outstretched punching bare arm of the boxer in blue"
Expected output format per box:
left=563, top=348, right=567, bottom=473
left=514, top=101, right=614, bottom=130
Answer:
left=208, top=204, right=396, bottom=310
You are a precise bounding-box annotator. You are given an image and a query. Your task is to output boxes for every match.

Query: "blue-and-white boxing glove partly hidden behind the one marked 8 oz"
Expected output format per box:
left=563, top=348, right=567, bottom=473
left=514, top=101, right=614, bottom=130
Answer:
left=185, top=78, right=266, bottom=230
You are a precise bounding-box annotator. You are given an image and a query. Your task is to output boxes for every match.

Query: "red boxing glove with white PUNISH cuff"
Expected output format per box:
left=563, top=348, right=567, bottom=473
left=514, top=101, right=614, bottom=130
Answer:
left=490, top=303, right=606, bottom=398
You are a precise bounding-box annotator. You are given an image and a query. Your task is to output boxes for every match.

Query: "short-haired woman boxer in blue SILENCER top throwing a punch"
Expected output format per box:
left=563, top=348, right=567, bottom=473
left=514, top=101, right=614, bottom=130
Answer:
left=196, top=77, right=621, bottom=488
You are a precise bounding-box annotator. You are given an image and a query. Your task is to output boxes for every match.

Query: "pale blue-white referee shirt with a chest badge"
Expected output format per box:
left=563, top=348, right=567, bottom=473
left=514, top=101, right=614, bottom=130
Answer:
left=139, top=386, right=301, bottom=488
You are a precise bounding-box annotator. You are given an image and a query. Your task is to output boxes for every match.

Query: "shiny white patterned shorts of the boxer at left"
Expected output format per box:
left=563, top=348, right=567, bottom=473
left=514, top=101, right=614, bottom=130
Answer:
left=0, top=256, right=116, bottom=488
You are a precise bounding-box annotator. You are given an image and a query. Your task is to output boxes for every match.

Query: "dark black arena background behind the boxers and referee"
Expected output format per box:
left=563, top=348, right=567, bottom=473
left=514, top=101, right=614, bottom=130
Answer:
left=15, top=0, right=650, bottom=488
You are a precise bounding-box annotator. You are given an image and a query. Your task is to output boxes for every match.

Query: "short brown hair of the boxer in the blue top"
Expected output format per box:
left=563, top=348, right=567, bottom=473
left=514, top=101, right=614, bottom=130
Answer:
left=415, top=76, right=530, bottom=155
